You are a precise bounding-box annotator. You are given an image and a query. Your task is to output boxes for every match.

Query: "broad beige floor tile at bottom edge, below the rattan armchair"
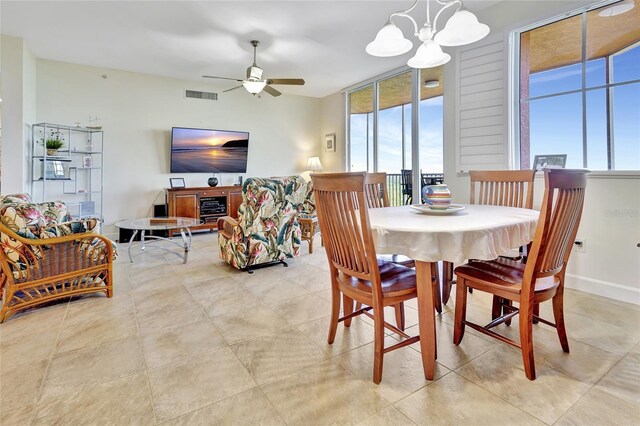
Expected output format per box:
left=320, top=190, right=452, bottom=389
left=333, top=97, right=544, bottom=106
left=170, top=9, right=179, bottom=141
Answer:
left=34, top=373, right=155, bottom=425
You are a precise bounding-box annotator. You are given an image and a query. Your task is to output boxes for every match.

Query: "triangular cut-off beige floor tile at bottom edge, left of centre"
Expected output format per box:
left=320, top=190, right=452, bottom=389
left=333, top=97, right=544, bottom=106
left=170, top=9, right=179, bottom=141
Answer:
left=167, top=388, right=284, bottom=426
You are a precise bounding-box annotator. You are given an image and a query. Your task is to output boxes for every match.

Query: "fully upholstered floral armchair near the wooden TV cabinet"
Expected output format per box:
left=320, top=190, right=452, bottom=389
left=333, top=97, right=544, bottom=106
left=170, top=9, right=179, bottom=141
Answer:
left=218, top=176, right=308, bottom=270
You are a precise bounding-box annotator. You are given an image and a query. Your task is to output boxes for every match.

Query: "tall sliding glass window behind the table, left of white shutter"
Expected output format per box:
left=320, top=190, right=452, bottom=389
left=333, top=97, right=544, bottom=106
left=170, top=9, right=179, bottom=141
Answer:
left=347, top=67, right=444, bottom=205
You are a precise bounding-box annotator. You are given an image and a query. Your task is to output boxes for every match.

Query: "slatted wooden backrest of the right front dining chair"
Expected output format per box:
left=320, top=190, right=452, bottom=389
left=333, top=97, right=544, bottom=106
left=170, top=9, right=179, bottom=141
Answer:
left=522, top=169, right=589, bottom=294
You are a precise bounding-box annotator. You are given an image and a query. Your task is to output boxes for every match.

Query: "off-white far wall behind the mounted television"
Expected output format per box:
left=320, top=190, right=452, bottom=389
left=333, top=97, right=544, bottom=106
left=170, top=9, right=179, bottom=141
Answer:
left=37, top=59, right=321, bottom=236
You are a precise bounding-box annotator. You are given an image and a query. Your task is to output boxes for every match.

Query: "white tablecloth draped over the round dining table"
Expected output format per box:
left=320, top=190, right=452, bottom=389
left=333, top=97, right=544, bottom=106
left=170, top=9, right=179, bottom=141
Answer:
left=369, top=205, right=540, bottom=263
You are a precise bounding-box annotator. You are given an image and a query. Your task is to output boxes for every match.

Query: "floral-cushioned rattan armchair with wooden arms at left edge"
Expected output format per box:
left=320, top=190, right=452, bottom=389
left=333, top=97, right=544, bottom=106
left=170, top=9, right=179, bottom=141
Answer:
left=0, top=194, right=115, bottom=322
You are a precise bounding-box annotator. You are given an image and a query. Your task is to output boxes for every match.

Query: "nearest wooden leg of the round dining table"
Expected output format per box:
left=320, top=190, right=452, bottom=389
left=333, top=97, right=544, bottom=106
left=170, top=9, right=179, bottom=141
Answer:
left=416, top=261, right=436, bottom=380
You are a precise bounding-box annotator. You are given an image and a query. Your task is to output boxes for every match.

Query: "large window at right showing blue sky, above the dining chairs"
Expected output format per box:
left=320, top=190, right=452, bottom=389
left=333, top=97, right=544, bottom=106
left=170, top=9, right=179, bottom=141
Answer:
left=518, top=4, right=640, bottom=170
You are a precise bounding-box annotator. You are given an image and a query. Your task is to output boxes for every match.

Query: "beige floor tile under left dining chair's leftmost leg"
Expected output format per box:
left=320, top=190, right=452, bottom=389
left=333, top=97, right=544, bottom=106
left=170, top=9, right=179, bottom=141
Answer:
left=297, top=317, right=374, bottom=356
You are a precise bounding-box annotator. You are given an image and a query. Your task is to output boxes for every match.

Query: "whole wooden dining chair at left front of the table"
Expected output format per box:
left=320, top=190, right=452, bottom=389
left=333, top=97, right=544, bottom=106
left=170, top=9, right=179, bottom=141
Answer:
left=311, top=172, right=424, bottom=384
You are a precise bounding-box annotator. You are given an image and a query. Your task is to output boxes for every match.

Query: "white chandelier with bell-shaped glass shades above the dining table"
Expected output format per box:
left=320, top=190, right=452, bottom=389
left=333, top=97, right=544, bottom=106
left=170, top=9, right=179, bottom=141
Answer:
left=366, top=0, right=489, bottom=68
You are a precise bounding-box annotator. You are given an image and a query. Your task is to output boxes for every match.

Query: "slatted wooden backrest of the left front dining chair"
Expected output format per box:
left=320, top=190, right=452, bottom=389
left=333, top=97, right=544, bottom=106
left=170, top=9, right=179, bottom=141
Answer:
left=311, top=172, right=381, bottom=282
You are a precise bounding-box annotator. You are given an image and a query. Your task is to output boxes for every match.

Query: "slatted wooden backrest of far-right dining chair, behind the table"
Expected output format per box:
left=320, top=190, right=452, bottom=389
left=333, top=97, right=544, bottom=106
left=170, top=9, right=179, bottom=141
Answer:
left=469, top=170, right=535, bottom=209
